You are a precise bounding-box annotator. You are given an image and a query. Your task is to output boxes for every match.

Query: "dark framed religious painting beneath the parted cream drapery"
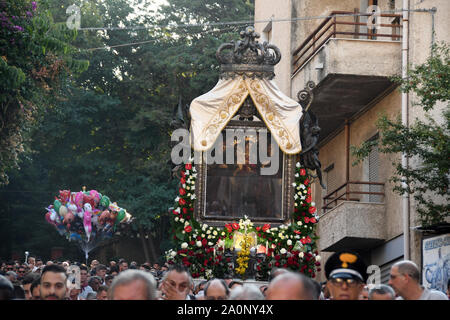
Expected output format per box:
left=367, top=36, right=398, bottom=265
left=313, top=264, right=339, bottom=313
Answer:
left=203, top=122, right=283, bottom=221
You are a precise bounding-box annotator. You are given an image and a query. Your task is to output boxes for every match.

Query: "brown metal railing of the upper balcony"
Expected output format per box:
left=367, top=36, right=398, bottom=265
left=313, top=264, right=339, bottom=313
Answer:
left=292, top=11, right=402, bottom=74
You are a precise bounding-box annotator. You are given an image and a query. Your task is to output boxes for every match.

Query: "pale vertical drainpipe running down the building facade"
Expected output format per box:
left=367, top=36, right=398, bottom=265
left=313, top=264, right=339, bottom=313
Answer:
left=402, top=0, right=410, bottom=260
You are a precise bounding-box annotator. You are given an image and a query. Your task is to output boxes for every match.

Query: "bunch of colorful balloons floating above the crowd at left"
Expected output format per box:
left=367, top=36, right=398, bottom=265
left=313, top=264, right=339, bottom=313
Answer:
left=45, top=188, right=133, bottom=243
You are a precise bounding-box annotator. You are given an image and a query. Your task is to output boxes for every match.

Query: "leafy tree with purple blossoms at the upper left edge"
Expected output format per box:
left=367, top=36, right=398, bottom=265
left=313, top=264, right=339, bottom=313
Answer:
left=0, top=0, right=88, bottom=185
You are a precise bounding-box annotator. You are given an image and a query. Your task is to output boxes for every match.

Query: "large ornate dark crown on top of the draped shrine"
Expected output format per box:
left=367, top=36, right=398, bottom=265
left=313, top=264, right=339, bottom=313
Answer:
left=216, top=27, right=281, bottom=80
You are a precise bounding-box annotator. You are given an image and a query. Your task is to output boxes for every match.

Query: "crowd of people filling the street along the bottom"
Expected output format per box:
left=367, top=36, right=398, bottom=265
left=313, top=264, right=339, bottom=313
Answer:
left=0, top=251, right=450, bottom=300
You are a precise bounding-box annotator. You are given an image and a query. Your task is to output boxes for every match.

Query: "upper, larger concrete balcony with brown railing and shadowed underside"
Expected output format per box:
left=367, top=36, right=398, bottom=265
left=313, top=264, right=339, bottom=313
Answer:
left=291, top=11, right=401, bottom=140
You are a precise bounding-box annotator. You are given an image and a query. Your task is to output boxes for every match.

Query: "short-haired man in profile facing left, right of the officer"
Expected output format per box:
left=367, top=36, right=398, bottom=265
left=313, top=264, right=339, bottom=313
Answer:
left=389, top=260, right=448, bottom=300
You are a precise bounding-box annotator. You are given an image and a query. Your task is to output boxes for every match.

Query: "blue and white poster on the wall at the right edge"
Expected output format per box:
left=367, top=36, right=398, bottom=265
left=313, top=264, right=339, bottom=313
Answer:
left=422, top=234, right=450, bottom=293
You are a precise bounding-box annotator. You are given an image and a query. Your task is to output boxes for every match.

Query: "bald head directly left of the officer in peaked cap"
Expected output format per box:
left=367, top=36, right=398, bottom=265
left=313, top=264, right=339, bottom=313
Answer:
left=266, top=272, right=314, bottom=300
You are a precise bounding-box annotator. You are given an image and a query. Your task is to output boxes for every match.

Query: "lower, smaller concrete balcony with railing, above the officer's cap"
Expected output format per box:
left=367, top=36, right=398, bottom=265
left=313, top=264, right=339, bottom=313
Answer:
left=319, top=181, right=386, bottom=252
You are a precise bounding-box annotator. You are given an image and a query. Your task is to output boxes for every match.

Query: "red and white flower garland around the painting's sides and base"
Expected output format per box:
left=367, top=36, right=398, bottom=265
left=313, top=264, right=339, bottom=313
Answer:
left=166, top=160, right=320, bottom=279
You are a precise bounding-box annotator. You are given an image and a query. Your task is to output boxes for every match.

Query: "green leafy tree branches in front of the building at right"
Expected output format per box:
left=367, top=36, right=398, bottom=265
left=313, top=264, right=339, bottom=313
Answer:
left=352, top=43, right=450, bottom=226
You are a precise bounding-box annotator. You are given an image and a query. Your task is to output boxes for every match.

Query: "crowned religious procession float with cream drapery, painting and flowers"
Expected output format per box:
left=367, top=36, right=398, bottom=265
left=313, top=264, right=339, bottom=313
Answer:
left=166, top=27, right=322, bottom=281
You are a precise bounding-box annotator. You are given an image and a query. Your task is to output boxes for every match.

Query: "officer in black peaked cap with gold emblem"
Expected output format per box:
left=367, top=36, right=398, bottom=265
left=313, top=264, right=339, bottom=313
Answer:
left=325, top=251, right=367, bottom=300
